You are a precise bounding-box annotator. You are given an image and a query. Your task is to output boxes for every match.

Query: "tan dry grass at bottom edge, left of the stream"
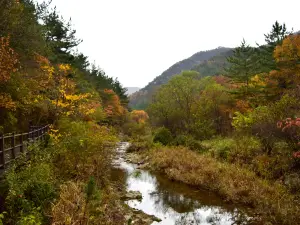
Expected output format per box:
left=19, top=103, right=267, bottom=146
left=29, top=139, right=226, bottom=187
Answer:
left=51, top=181, right=125, bottom=225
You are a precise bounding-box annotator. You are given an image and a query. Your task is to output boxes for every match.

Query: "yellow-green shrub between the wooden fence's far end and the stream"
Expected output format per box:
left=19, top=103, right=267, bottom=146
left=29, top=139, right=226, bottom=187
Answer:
left=50, top=119, right=117, bottom=180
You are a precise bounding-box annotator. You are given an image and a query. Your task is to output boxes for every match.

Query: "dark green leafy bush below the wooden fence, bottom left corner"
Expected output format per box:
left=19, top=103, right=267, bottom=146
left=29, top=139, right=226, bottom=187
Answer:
left=6, top=161, right=56, bottom=224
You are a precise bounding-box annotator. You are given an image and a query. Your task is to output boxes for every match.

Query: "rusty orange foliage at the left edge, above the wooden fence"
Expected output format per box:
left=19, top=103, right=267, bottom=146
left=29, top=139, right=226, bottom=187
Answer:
left=0, top=37, right=18, bottom=82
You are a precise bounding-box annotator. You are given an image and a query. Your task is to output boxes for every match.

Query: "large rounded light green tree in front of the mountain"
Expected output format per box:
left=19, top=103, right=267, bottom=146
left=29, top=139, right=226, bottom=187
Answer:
left=148, top=72, right=231, bottom=139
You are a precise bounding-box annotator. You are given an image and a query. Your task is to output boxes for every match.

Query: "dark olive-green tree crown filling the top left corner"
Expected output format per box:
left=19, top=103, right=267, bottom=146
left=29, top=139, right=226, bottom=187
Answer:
left=0, top=0, right=47, bottom=59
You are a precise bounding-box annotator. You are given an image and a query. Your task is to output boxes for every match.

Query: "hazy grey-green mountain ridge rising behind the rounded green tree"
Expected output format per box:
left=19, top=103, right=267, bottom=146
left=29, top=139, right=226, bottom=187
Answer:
left=129, top=47, right=232, bottom=109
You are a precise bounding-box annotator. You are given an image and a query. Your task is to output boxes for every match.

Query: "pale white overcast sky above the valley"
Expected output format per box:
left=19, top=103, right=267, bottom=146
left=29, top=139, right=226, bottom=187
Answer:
left=44, top=0, right=300, bottom=87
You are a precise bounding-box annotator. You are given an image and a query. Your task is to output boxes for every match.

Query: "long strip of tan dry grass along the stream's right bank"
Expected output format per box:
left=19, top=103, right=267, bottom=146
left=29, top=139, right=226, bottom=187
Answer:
left=149, top=147, right=300, bottom=224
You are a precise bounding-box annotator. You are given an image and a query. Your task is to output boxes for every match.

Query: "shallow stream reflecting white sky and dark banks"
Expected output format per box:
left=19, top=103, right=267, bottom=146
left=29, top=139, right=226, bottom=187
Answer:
left=112, top=142, right=252, bottom=225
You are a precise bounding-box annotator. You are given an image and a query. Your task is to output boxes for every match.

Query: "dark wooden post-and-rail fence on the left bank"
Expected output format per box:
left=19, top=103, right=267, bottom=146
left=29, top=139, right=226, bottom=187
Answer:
left=0, top=125, right=49, bottom=170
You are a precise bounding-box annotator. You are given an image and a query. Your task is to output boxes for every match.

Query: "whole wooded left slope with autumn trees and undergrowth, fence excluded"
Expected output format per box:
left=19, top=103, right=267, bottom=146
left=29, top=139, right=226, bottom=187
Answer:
left=0, top=0, right=128, bottom=225
